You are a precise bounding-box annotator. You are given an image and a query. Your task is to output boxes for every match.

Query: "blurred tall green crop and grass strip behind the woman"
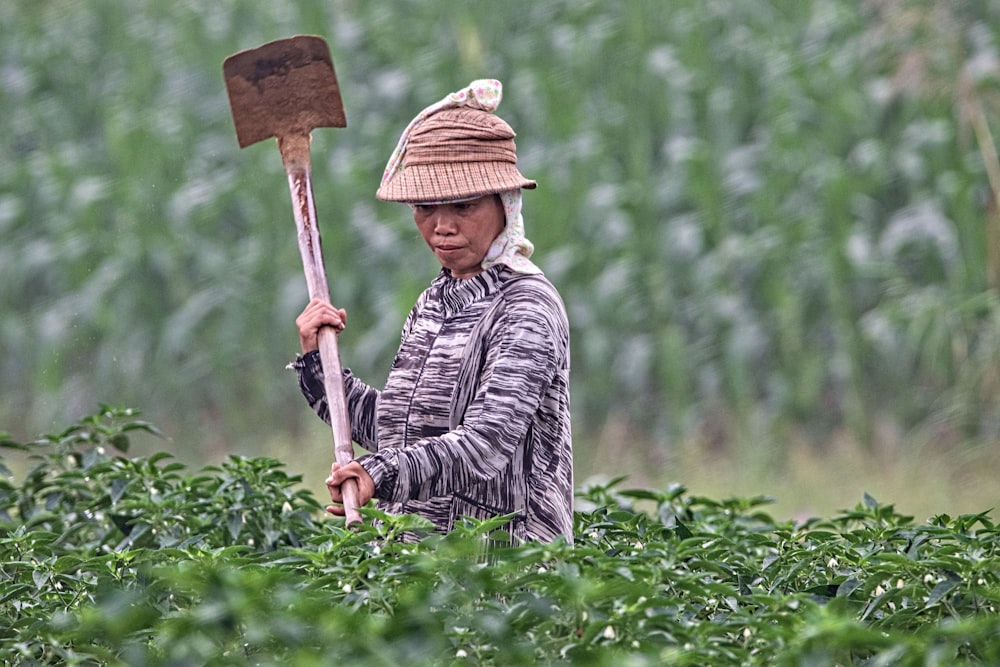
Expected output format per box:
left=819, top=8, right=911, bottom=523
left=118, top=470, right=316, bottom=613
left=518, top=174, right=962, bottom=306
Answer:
left=0, top=0, right=1000, bottom=516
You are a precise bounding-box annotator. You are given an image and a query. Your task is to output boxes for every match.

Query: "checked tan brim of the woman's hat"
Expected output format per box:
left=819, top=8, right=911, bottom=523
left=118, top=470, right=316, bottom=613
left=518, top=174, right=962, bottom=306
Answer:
left=375, top=162, right=538, bottom=204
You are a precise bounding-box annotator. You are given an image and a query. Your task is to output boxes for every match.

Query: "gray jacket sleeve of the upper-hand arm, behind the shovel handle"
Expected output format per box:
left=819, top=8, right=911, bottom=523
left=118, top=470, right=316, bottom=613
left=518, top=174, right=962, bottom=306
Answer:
left=289, top=350, right=379, bottom=452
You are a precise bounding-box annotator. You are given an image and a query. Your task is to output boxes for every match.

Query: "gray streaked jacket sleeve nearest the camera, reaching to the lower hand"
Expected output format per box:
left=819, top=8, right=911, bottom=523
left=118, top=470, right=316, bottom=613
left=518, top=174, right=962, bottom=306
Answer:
left=360, top=290, right=569, bottom=502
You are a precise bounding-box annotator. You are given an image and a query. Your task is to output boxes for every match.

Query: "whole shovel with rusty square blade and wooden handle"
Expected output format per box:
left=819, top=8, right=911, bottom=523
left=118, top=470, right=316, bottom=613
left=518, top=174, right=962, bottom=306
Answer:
left=222, top=35, right=361, bottom=526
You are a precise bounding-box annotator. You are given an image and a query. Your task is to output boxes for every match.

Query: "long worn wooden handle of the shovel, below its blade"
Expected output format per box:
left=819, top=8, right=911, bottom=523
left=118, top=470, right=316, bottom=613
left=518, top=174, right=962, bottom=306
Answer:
left=278, top=134, right=361, bottom=526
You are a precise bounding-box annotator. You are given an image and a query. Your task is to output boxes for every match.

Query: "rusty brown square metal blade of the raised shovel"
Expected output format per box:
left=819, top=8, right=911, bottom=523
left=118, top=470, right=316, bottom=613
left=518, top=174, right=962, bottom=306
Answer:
left=222, top=35, right=347, bottom=148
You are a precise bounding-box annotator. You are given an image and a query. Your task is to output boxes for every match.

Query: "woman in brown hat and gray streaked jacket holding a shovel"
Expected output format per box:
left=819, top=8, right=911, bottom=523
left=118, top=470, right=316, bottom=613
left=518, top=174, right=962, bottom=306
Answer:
left=292, top=80, right=573, bottom=542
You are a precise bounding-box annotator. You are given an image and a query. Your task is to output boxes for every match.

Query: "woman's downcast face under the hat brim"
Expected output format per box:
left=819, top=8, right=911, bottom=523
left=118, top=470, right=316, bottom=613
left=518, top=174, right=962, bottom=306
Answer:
left=413, top=195, right=505, bottom=279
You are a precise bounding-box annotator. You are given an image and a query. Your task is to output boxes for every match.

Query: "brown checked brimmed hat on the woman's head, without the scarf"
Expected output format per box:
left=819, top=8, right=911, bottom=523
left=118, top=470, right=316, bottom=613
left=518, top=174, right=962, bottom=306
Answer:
left=376, top=107, right=537, bottom=203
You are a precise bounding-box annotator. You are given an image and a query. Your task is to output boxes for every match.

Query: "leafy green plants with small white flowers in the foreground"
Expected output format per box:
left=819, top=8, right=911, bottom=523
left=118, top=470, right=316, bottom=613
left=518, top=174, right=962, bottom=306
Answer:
left=0, top=407, right=1000, bottom=666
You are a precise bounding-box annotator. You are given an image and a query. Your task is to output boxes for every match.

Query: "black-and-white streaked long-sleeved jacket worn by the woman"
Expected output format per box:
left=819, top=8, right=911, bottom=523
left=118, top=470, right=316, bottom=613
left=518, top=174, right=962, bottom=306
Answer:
left=292, top=265, right=573, bottom=541
